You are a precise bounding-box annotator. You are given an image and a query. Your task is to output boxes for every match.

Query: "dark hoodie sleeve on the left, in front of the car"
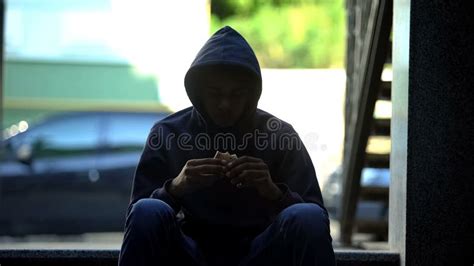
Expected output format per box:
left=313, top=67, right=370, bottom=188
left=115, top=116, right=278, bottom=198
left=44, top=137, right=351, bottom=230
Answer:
left=130, top=123, right=181, bottom=213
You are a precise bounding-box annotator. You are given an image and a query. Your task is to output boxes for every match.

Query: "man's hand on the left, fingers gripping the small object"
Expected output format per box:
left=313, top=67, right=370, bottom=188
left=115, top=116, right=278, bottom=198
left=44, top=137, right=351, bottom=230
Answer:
left=169, top=158, right=226, bottom=197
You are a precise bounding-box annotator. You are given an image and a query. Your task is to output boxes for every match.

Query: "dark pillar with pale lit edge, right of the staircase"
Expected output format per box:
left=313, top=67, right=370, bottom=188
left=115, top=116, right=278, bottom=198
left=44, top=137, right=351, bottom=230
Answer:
left=389, top=0, right=474, bottom=265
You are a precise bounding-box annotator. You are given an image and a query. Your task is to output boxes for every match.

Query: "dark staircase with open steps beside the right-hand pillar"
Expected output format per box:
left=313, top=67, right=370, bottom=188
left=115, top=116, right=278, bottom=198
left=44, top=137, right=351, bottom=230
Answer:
left=341, top=0, right=393, bottom=246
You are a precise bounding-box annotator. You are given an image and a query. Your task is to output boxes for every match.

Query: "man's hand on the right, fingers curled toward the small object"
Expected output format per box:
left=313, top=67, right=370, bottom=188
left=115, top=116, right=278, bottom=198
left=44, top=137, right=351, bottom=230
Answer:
left=226, top=156, right=282, bottom=200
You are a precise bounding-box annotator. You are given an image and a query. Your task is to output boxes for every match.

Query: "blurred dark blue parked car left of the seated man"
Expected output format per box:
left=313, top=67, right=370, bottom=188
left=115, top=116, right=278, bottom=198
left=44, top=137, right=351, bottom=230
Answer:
left=0, top=112, right=167, bottom=235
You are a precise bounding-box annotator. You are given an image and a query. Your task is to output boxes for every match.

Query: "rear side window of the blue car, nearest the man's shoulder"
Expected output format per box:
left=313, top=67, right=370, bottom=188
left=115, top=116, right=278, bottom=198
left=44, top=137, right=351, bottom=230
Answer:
left=106, top=113, right=163, bottom=151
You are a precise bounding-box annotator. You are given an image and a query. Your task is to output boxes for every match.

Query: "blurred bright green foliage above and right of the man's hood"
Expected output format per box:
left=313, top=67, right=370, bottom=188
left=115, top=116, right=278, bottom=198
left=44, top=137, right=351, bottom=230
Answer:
left=211, top=0, right=345, bottom=68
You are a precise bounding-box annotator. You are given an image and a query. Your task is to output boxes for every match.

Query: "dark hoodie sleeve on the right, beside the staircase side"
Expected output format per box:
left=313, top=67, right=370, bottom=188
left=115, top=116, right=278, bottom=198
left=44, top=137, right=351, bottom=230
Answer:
left=274, top=128, right=324, bottom=215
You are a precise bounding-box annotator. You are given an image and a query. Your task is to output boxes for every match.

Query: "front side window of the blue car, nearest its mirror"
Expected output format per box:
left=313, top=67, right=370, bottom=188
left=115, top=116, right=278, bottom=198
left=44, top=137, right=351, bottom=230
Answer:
left=16, top=114, right=100, bottom=157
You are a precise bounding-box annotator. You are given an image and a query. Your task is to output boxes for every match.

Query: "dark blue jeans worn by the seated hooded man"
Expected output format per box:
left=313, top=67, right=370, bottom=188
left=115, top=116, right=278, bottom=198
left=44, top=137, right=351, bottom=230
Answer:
left=119, top=199, right=335, bottom=266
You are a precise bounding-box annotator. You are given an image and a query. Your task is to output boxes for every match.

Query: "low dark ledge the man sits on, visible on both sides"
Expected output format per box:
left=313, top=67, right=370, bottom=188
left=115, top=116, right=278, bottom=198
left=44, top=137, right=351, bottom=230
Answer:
left=0, top=249, right=400, bottom=266
